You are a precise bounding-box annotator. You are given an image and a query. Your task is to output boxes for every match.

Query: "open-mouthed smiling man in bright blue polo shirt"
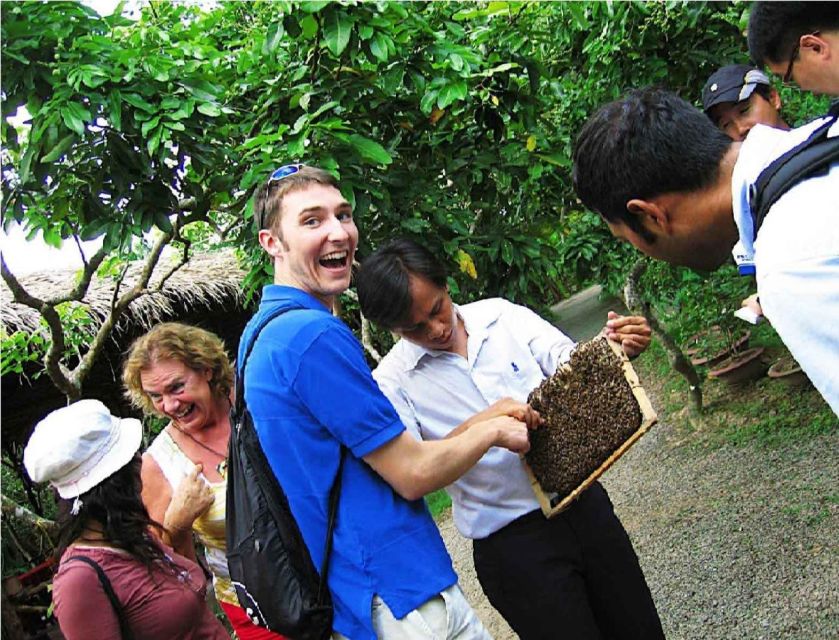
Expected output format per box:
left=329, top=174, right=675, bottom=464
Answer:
left=239, top=165, right=535, bottom=640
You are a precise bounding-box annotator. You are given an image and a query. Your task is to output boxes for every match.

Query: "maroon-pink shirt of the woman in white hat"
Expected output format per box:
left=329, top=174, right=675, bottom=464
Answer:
left=52, top=546, right=229, bottom=640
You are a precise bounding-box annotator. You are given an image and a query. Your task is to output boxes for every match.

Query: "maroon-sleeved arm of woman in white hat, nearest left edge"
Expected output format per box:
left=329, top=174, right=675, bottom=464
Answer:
left=52, top=560, right=121, bottom=640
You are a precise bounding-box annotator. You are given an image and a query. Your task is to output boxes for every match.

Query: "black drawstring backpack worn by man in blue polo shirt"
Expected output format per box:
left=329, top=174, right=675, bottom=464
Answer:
left=226, top=309, right=344, bottom=640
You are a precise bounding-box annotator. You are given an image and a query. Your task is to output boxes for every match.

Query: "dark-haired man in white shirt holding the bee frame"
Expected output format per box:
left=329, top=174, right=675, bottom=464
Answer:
left=357, top=240, right=663, bottom=640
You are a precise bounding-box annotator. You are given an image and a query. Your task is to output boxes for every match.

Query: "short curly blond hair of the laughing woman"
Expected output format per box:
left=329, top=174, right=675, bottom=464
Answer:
left=122, top=322, right=233, bottom=415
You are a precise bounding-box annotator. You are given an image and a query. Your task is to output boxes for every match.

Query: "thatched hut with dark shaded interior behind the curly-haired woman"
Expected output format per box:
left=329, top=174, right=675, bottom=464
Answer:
left=0, top=251, right=250, bottom=447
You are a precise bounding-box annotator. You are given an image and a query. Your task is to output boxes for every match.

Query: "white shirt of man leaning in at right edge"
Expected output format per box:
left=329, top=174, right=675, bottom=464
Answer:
left=732, top=120, right=839, bottom=415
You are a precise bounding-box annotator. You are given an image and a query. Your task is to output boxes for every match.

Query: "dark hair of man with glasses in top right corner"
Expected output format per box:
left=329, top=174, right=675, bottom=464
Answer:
left=748, top=1, right=839, bottom=67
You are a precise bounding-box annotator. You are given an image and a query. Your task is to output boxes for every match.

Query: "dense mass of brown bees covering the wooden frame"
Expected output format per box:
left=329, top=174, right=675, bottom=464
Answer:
left=526, top=338, right=642, bottom=496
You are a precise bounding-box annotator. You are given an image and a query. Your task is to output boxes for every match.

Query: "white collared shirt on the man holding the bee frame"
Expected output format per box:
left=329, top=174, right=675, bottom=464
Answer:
left=373, top=298, right=575, bottom=538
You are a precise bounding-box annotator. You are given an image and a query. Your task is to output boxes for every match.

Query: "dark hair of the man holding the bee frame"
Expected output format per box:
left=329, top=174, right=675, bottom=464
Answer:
left=356, top=238, right=448, bottom=329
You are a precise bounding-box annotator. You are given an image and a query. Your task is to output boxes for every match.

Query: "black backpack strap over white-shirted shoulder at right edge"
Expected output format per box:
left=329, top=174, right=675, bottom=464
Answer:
left=749, top=117, right=839, bottom=237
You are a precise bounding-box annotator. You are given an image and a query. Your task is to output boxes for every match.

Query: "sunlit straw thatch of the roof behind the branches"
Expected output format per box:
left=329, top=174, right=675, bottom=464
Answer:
left=0, top=250, right=245, bottom=333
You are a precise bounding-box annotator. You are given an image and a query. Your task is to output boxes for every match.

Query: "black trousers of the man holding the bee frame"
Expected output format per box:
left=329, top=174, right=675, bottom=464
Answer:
left=473, top=483, right=664, bottom=640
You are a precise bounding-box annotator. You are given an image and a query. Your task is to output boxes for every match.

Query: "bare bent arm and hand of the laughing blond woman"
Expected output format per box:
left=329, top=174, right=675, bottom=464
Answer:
left=140, top=453, right=213, bottom=560
